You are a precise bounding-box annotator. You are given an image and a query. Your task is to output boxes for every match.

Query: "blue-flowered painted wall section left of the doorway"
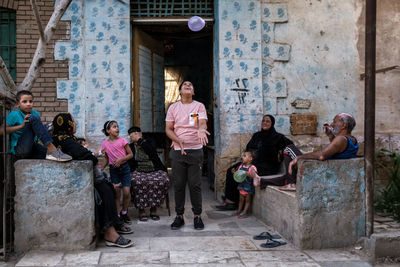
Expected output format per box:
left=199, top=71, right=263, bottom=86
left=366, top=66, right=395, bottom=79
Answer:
left=54, top=0, right=131, bottom=142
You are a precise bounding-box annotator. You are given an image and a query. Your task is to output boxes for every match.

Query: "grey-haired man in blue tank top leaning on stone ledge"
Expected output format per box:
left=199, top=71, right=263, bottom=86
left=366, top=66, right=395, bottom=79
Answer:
left=289, top=113, right=358, bottom=188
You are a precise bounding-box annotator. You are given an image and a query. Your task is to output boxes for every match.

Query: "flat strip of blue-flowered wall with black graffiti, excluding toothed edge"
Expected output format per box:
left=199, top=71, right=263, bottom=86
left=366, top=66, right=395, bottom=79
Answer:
left=218, top=0, right=263, bottom=134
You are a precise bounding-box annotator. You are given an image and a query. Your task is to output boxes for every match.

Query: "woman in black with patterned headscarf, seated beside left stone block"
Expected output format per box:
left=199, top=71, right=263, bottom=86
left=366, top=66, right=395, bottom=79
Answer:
left=53, top=113, right=133, bottom=248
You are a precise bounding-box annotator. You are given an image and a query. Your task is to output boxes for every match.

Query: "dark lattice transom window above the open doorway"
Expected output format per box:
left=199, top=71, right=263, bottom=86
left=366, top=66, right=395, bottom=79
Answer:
left=131, top=0, right=214, bottom=18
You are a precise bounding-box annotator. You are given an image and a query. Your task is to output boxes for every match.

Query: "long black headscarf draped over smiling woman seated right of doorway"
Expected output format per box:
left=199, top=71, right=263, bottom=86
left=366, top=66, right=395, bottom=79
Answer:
left=246, top=115, right=293, bottom=175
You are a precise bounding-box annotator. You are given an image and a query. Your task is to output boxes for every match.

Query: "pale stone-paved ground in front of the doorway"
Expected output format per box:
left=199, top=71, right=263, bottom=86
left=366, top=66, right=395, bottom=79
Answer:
left=0, top=177, right=390, bottom=267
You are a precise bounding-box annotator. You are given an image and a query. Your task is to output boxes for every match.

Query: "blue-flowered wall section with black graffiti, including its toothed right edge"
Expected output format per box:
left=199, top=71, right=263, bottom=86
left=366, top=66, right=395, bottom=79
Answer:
left=218, top=0, right=290, bottom=136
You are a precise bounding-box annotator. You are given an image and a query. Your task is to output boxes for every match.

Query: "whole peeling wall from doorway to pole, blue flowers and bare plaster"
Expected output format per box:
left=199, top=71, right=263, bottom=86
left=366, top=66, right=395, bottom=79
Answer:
left=214, top=0, right=361, bottom=193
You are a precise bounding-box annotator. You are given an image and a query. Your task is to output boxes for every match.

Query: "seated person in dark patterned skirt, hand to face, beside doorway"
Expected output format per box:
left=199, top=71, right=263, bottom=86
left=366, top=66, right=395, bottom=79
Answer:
left=128, top=127, right=169, bottom=221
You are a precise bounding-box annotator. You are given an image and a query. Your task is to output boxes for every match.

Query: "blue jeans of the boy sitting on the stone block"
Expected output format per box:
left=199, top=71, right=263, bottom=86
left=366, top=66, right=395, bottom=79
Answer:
left=14, top=115, right=53, bottom=159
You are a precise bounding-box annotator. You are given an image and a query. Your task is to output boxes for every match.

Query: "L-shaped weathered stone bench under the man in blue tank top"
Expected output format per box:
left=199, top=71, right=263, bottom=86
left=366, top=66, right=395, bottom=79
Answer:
left=252, top=158, right=366, bottom=249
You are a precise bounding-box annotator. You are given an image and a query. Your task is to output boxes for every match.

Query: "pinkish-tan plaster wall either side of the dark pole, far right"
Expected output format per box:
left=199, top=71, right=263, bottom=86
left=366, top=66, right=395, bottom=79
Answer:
left=356, top=0, right=400, bottom=151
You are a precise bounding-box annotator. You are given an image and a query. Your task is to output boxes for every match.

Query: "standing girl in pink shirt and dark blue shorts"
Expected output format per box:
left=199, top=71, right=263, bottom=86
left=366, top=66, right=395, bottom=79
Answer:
left=101, top=121, right=133, bottom=223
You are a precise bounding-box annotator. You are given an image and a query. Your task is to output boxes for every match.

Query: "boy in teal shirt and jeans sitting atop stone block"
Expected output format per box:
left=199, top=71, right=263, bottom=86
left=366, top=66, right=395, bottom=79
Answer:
left=6, top=90, right=72, bottom=161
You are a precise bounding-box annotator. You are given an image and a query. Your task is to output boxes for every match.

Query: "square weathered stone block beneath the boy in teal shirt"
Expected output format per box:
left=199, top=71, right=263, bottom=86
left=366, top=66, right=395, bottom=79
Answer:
left=14, top=160, right=95, bottom=252
